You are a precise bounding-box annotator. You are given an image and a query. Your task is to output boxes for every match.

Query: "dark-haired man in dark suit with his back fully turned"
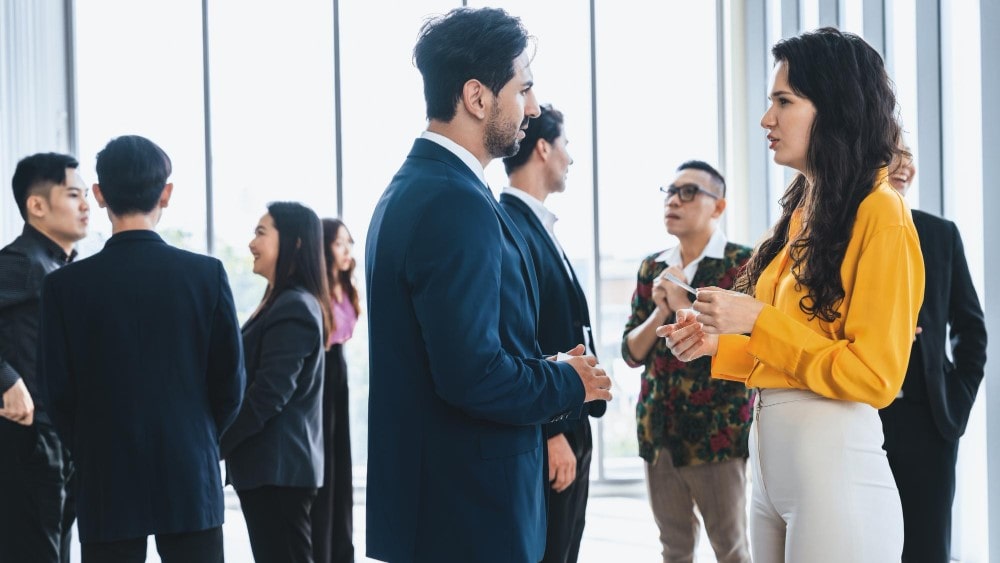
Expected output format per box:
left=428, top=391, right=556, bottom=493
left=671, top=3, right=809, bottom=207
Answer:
left=38, top=136, right=245, bottom=563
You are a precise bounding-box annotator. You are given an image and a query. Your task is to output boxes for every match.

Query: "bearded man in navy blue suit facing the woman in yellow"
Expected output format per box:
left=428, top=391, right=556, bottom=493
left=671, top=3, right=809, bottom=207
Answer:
left=365, top=8, right=611, bottom=563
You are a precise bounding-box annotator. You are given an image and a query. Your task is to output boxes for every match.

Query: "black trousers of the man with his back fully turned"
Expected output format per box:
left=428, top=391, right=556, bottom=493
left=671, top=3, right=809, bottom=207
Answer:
left=80, top=526, right=225, bottom=563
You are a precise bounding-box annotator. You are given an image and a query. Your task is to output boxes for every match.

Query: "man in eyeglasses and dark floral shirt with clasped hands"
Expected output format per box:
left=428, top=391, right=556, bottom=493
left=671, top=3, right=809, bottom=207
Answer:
left=622, top=160, right=751, bottom=563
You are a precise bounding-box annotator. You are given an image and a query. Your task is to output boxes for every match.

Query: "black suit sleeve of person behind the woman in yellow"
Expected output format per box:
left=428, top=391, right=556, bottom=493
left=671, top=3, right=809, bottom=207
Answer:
left=947, top=223, right=986, bottom=412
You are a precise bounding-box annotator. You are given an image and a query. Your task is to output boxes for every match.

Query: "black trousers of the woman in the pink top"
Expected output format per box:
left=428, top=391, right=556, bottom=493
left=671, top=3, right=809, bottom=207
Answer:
left=311, top=344, right=362, bottom=563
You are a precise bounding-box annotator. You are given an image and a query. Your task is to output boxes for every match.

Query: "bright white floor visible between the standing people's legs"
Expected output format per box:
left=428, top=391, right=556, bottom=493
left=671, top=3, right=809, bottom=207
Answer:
left=73, top=482, right=728, bottom=563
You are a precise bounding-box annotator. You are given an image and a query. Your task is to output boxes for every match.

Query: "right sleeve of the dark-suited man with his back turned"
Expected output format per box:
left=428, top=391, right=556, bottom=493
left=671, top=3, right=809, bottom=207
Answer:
left=206, top=262, right=246, bottom=435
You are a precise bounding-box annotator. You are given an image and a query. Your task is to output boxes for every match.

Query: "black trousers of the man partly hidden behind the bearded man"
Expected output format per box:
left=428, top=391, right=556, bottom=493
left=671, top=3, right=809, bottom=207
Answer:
left=542, top=416, right=594, bottom=563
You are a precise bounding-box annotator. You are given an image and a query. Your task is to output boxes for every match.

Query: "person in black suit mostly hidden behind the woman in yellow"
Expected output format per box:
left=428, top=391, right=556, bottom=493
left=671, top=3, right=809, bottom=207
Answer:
left=879, top=143, right=986, bottom=563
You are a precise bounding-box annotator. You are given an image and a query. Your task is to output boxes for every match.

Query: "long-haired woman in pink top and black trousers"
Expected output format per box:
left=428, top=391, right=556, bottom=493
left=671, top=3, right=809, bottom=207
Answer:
left=312, top=219, right=361, bottom=563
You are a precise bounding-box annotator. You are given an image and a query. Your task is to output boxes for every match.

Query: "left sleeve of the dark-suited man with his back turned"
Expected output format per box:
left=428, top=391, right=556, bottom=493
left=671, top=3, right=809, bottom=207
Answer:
left=36, top=276, right=77, bottom=449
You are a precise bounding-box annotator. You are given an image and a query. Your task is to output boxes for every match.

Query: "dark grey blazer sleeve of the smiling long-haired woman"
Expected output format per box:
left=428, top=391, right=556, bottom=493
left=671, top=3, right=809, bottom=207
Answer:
left=219, top=297, right=322, bottom=458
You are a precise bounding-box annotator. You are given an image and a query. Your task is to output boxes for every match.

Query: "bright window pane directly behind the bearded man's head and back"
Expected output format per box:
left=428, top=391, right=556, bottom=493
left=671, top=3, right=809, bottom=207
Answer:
left=340, top=0, right=459, bottom=476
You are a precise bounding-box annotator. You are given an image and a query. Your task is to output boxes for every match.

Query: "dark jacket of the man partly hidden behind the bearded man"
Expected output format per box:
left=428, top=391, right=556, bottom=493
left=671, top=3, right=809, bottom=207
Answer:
left=500, top=194, right=608, bottom=438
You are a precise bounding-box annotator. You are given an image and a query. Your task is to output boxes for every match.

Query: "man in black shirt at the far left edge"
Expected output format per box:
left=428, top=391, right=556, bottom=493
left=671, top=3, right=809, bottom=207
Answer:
left=0, top=153, right=90, bottom=563
